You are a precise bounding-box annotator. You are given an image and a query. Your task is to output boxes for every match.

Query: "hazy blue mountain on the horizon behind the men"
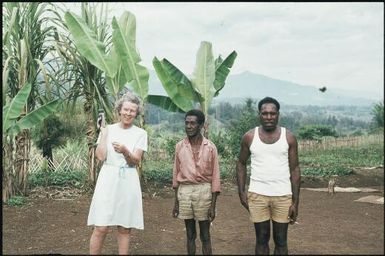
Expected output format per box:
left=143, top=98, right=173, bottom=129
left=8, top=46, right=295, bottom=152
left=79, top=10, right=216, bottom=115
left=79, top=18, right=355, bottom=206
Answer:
left=149, top=70, right=377, bottom=106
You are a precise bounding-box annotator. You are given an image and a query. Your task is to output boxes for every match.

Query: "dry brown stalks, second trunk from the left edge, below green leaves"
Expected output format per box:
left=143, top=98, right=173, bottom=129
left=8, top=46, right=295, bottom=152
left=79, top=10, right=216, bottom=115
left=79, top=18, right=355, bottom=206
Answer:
left=15, top=130, right=31, bottom=195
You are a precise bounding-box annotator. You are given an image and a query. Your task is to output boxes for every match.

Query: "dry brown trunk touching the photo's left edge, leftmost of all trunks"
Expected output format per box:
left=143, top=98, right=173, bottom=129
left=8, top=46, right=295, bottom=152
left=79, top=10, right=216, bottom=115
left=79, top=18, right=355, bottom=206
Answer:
left=2, top=136, right=15, bottom=203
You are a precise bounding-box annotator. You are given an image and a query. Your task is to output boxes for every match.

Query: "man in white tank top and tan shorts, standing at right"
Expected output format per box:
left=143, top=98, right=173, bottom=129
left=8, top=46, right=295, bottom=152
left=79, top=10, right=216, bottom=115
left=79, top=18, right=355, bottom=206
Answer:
left=236, top=97, right=301, bottom=255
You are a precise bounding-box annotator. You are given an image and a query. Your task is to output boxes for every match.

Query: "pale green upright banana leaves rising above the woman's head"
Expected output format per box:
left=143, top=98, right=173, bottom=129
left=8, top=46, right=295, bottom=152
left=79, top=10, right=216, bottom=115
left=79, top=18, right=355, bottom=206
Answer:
left=64, top=11, right=149, bottom=120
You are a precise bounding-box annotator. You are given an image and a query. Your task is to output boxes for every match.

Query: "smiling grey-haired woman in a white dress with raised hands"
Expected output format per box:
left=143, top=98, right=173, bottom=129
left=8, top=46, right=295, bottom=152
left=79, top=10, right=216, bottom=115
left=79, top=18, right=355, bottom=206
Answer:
left=87, top=93, right=147, bottom=254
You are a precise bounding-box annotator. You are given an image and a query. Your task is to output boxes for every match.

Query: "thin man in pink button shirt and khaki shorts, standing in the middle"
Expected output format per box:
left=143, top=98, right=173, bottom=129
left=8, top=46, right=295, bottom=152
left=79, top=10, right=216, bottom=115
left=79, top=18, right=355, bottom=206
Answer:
left=172, top=109, right=221, bottom=255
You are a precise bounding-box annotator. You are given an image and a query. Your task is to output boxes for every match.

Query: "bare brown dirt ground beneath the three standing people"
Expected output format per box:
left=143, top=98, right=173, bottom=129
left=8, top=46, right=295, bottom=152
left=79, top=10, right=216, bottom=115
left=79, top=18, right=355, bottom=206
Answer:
left=2, top=169, right=384, bottom=255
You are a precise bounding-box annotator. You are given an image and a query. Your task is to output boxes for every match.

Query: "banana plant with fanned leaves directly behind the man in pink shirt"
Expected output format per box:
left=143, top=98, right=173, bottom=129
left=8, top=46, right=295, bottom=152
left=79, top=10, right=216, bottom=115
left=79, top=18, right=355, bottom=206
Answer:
left=148, top=41, right=237, bottom=137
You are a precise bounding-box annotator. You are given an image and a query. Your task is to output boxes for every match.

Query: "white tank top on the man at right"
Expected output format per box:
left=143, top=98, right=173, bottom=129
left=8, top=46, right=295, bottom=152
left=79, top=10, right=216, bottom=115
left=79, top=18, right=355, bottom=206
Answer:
left=249, top=127, right=292, bottom=196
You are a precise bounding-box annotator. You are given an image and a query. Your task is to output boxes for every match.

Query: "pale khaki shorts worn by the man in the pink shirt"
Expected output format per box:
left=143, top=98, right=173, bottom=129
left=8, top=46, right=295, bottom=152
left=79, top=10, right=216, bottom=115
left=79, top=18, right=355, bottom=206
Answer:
left=178, top=183, right=212, bottom=221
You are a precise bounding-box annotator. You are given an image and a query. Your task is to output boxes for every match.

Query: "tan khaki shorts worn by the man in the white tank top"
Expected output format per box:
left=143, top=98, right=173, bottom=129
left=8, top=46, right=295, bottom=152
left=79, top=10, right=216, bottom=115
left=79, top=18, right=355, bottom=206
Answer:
left=247, top=192, right=292, bottom=223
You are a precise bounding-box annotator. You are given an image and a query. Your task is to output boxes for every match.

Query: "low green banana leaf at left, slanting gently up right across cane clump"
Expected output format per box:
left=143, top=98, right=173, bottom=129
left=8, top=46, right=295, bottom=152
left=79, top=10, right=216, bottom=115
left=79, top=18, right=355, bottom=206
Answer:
left=10, top=99, right=61, bottom=134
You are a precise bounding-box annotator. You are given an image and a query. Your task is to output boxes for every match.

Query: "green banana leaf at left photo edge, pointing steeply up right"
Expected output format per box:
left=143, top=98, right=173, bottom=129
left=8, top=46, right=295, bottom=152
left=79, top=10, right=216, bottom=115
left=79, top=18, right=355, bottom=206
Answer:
left=3, top=83, right=31, bottom=132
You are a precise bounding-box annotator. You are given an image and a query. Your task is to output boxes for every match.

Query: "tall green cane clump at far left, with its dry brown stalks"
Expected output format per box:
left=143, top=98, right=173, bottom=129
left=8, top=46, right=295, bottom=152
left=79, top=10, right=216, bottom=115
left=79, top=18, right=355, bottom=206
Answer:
left=2, top=2, right=58, bottom=202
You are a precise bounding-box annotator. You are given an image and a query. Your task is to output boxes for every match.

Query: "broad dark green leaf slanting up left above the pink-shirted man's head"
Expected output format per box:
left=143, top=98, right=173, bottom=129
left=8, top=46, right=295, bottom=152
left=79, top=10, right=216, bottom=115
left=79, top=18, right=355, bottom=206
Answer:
left=152, top=57, right=197, bottom=112
